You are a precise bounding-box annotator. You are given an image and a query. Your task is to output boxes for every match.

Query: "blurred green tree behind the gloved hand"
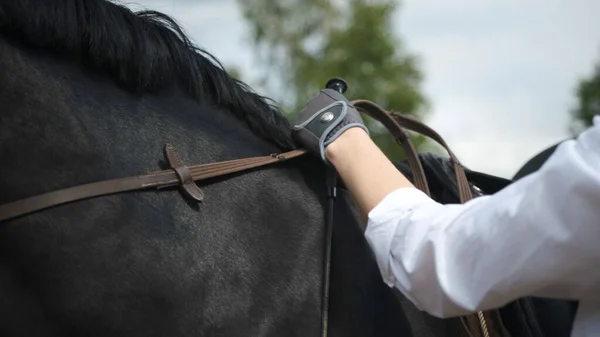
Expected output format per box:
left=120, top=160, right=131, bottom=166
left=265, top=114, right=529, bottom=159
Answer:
left=238, top=0, right=427, bottom=160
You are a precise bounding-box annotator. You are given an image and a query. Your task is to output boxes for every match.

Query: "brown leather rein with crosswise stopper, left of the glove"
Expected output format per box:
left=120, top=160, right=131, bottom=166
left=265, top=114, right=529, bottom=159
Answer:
left=0, top=144, right=306, bottom=222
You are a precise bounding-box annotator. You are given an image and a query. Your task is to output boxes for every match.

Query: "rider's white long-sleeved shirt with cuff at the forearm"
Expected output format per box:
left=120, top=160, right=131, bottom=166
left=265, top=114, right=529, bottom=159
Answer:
left=365, top=116, right=600, bottom=337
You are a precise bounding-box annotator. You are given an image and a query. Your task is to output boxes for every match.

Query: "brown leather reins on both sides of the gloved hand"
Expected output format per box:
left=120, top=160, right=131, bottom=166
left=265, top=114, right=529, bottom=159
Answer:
left=0, top=100, right=501, bottom=337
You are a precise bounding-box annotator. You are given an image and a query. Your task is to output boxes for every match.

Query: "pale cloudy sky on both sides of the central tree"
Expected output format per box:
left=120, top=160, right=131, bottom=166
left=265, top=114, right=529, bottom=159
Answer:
left=121, top=0, right=600, bottom=178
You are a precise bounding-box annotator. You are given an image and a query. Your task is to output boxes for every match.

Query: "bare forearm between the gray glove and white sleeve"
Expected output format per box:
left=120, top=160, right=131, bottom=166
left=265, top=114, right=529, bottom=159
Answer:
left=325, top=128, right=414, bottom=215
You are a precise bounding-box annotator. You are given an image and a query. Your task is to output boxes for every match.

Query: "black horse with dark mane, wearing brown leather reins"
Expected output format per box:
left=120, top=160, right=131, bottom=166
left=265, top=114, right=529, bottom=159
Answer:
left=0, top=0, right=576, bottom=337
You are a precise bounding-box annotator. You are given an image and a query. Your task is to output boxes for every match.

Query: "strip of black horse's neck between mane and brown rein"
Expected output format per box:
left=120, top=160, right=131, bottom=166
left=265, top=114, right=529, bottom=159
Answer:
left=0, top=35, right=277, bottom=186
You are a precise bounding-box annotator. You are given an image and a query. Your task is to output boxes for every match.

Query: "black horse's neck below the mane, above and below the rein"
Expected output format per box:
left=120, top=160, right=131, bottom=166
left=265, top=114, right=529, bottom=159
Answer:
left=0, top=34, right=336, bottom=335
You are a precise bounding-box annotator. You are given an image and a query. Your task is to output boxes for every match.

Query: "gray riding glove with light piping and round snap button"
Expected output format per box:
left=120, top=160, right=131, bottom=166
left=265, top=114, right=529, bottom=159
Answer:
left=293, top=89, right=369, bottom=164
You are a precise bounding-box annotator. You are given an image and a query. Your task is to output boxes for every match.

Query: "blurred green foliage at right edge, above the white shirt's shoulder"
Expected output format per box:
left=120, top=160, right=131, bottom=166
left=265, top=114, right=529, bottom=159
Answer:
left=571, top=54, right=600, bottom=135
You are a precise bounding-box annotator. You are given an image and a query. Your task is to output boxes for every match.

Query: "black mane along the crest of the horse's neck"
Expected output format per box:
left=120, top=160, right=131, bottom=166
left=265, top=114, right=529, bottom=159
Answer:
left=0, top=0, right=294, bottom=149
